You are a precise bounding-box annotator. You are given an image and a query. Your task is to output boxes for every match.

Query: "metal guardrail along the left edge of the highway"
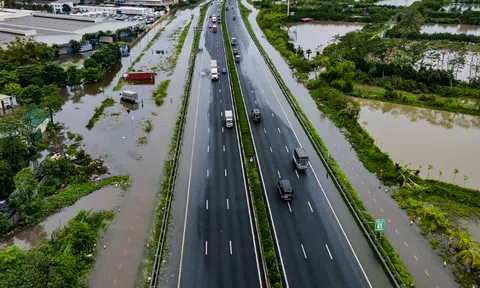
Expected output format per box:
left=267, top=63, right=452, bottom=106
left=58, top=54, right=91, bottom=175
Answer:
left=150, top=27, right=202, bottom=288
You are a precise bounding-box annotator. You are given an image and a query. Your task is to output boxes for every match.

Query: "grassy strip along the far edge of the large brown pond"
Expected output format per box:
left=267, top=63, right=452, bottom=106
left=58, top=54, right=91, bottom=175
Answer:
left=349, top=85, right=480, bottom=116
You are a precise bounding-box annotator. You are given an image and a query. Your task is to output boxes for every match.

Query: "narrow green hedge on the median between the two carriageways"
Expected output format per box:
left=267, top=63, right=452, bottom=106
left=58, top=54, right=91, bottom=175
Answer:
left=222, top=2, right=282, bottom=287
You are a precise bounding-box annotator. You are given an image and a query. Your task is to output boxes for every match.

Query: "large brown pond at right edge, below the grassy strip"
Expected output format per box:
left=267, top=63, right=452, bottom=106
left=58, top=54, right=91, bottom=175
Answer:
left=354, top=98, right=480, bottom=189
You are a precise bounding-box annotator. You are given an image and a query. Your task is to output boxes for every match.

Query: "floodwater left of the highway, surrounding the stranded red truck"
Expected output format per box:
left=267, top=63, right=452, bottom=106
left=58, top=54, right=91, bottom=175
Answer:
left=0, top=9, right=198, bottom=287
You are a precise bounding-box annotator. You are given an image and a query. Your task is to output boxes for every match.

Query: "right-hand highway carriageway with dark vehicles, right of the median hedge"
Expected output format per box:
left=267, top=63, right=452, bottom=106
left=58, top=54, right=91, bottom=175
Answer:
left=225, top=0, right=388, bottom=288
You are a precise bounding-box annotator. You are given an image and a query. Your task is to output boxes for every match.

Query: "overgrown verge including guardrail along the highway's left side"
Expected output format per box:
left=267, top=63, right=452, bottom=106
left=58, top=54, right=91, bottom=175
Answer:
left=139, top=3, right=210, bottom=287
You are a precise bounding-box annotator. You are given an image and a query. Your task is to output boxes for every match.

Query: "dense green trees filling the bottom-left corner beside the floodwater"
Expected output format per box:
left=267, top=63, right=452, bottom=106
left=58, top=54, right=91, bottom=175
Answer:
left=0, top=210, right=114, bottom=288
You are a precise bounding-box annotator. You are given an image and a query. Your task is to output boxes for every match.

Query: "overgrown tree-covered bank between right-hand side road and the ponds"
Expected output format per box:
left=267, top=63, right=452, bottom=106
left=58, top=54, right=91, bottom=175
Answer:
left=249, top=0, right=480, bottom=287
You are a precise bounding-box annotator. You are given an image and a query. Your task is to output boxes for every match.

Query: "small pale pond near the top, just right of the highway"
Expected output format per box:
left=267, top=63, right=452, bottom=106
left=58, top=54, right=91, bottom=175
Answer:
left=286, top=21, right=365, bottom=56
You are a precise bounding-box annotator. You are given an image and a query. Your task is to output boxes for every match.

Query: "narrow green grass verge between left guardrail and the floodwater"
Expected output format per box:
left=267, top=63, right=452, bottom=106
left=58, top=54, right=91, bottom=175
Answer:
left=140, top=1, right=211, bottom=287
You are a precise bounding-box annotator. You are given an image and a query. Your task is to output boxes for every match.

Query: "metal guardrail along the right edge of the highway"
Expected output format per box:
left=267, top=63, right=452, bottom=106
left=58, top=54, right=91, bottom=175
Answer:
left=238, top=5, right=406, bottom=287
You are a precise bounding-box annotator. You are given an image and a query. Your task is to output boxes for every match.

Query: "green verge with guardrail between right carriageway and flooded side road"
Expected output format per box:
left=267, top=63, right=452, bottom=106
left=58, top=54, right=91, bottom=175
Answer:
left=239, top=2, right=415, bottom=287
